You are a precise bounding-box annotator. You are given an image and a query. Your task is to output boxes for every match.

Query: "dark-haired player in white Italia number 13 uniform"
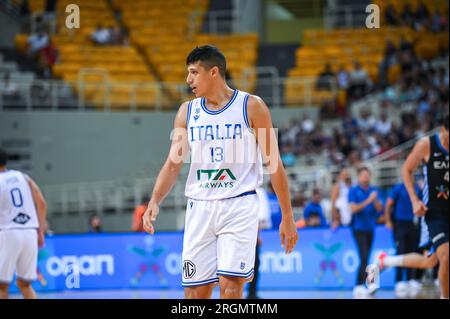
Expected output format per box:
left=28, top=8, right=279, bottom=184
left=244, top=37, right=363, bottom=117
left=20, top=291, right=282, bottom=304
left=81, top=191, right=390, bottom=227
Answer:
left=143, top=45, right=298, bottom=298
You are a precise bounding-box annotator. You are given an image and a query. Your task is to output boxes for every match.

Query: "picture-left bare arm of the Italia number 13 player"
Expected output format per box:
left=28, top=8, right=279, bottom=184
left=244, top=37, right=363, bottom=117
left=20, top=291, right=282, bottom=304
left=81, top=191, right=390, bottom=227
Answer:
left=142, top=102, right=189, bottom=235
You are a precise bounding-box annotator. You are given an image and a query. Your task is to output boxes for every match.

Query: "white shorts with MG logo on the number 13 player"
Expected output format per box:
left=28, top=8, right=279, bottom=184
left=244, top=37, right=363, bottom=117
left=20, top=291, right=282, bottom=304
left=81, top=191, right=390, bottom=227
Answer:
left=182, top=194, right=259, bottom=287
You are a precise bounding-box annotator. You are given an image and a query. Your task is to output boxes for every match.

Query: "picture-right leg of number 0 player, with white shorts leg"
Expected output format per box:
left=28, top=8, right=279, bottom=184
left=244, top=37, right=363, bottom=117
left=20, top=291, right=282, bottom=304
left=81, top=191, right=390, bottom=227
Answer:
left=16, top=229, right=38, bottom=299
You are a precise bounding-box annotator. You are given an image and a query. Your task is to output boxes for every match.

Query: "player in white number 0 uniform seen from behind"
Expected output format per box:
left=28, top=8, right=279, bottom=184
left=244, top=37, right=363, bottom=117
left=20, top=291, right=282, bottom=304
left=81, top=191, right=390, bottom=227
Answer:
left=0, top=149, right=47, bottom=299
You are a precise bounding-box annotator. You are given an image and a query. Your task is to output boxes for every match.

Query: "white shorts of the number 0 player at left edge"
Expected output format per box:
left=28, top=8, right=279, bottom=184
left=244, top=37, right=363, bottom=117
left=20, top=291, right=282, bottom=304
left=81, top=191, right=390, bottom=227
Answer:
left=0, top=229, right=38, bottom=283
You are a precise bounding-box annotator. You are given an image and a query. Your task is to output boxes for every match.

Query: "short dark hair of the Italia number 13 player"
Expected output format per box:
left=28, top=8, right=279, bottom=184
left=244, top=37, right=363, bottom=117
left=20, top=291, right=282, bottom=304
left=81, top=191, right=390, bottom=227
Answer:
left=186, top=45, right=227, bottom=79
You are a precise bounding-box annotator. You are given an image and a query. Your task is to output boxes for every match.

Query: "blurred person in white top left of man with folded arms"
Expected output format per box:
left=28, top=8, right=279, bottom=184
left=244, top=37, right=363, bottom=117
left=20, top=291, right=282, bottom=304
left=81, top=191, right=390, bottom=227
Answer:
left=331, top=167, right=352, bottom=229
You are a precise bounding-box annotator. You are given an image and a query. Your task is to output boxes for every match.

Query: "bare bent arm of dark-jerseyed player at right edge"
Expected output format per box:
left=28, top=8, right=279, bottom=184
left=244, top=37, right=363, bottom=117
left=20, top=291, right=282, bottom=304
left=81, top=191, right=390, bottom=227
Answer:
left=402, top=137, right=430, bottom=216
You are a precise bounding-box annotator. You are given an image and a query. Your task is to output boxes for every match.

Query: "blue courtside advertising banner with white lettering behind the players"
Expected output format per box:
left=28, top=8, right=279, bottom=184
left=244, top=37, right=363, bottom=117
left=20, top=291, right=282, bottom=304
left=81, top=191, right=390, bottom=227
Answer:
left=8, top=227, right=395, bottom=291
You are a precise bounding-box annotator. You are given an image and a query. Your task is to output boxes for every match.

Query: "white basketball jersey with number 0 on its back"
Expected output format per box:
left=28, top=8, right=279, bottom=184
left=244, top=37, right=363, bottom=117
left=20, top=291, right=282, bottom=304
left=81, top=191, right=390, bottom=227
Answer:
left=0, top=170, right=39, bottom=230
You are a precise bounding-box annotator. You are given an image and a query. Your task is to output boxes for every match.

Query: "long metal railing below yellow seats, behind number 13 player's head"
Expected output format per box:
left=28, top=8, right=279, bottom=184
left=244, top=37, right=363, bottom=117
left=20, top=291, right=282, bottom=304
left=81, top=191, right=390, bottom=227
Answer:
left=0, top=75, right=337, bottom=111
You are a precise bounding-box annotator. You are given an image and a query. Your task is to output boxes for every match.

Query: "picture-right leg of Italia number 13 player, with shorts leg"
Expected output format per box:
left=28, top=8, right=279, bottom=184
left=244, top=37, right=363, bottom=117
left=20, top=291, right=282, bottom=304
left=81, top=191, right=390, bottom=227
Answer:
left=217, top=195, right=259, bottom=298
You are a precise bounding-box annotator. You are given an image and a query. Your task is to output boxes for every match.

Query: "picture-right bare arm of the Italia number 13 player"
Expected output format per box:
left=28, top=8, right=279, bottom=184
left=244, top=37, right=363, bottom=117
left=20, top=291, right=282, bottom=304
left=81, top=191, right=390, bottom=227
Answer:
left=247, top=95, right=298, bottom=254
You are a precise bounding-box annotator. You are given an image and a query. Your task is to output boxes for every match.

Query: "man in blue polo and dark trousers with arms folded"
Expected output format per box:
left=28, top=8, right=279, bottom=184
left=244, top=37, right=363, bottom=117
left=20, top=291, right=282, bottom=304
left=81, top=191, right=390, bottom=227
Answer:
left=348, top=167, right=383, bottom=297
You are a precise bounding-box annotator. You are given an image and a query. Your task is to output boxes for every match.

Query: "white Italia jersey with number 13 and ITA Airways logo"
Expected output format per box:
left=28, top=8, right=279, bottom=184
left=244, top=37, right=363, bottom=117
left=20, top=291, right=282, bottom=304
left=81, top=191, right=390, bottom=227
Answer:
left=185, top=90, right=263, bottom=200
